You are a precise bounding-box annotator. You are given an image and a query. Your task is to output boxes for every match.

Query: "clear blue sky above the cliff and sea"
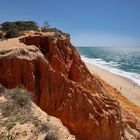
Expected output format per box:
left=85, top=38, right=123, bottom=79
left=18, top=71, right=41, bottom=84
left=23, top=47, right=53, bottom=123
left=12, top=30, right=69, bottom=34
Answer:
left=0, top=0, right=140, bottom=47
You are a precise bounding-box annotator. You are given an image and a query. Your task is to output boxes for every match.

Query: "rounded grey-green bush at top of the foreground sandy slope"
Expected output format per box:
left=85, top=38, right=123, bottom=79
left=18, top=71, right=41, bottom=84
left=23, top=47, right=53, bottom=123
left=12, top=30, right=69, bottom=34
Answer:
left=12, top=88, right=30, bottom=106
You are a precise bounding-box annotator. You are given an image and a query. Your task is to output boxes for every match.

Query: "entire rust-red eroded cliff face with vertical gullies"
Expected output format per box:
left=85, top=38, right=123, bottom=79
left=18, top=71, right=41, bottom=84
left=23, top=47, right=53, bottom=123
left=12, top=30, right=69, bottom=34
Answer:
left=0, top=34, right=122, bottom=140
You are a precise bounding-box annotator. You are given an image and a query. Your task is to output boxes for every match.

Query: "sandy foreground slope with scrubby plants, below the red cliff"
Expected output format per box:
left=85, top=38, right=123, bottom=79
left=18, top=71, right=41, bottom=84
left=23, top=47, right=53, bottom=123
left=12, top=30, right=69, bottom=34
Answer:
left=0, top=85, right=74, bottom=140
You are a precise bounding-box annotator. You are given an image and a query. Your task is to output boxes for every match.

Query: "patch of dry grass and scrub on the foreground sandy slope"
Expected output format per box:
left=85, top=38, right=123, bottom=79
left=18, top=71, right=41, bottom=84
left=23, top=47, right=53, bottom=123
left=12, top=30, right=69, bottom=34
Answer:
left=0, top=86, right=49, bottom=133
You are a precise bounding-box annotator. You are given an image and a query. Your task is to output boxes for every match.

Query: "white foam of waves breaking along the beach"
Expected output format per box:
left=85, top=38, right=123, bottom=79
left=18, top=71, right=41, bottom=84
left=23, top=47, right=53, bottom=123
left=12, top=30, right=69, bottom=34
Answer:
left=81, top=56, right=140, bottom=86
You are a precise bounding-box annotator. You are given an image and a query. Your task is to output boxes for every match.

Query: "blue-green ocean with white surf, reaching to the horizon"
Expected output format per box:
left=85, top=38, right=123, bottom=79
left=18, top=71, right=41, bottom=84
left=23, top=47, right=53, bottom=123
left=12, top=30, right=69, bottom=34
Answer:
left=77, top=47, right=140, bottom=85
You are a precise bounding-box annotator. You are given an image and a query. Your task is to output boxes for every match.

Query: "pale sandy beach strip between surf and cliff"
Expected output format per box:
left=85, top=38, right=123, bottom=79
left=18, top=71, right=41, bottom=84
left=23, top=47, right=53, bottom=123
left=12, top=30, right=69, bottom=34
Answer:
left=86, top=63, right=140, bottom=107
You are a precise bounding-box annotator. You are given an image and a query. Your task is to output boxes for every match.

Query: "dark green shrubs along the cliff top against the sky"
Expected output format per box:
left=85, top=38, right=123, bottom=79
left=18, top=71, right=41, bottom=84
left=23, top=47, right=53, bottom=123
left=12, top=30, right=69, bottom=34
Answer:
left=0, top=20, right=70, bottom=38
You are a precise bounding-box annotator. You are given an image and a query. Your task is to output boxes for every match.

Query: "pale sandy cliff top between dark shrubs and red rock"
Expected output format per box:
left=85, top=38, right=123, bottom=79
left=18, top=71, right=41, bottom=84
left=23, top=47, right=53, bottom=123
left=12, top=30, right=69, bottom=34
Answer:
left=0, top=30, right=68, bottom=60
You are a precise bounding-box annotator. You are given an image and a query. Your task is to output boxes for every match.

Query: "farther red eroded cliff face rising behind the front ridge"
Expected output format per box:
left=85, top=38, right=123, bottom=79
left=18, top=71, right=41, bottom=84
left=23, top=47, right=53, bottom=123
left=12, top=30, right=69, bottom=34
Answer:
left=20, top=34, right=102, bottom=92
